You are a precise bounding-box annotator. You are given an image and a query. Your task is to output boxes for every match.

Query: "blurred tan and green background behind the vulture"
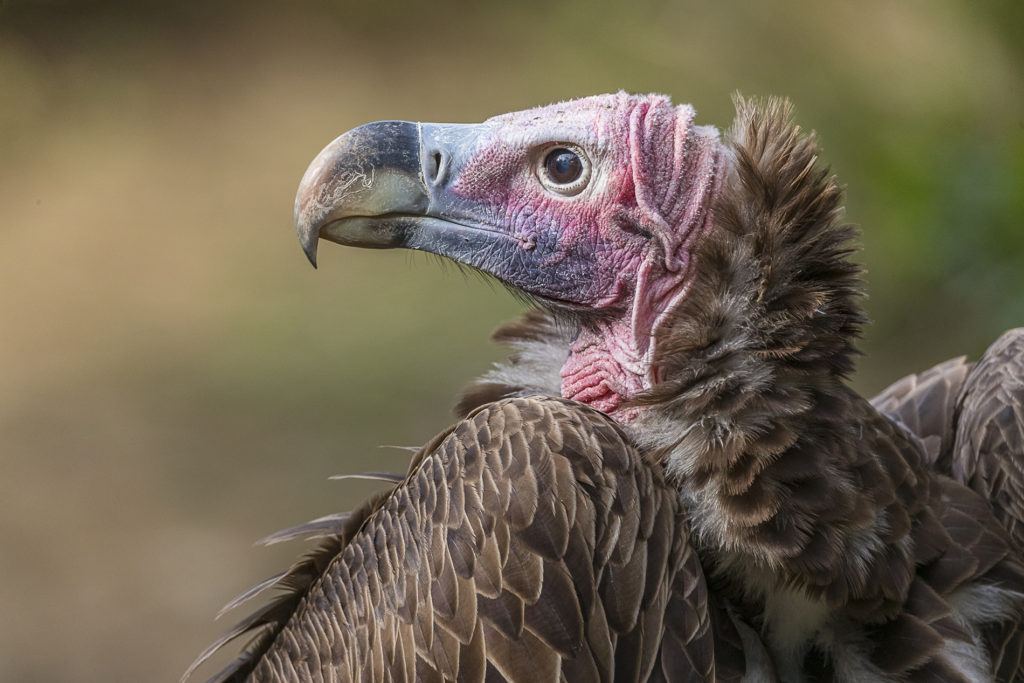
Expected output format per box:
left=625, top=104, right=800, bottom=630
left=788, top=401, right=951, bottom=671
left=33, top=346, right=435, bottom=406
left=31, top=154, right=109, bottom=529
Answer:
left=0, top=0, right=1024, bottom=682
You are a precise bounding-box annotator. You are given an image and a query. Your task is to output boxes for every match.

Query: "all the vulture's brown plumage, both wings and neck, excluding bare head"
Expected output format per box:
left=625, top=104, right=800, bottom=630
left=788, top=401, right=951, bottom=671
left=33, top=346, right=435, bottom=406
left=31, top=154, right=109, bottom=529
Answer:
left=193, top=94, right=1024, bottom=681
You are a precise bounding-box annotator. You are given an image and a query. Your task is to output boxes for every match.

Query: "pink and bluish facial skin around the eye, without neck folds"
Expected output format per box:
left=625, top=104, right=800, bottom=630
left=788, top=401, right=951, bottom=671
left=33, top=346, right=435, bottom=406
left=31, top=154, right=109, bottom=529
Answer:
left=445, top=97, right=652, bottom=308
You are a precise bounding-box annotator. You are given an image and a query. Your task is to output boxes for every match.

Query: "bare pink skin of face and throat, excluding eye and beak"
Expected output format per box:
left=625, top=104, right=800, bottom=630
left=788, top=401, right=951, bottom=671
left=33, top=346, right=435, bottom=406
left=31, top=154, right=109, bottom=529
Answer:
left=454, top=93, right=727, bottom=422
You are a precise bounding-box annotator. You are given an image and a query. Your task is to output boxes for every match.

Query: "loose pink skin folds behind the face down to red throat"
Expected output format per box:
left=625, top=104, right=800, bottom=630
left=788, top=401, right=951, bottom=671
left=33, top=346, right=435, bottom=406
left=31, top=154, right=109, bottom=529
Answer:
left=561, top=98, right=729, bottom=423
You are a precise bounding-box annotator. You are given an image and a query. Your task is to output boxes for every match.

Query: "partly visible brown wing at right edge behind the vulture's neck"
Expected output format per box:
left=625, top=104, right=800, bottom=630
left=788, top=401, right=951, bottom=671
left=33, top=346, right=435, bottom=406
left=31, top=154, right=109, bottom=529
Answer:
left=871, top=329, right=1024, bottom=681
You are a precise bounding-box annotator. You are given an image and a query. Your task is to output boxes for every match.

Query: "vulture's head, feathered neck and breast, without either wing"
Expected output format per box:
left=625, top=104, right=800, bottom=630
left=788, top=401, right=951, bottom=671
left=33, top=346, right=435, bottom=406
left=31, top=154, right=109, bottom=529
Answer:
left=276, top=93, right=1024, bottom=680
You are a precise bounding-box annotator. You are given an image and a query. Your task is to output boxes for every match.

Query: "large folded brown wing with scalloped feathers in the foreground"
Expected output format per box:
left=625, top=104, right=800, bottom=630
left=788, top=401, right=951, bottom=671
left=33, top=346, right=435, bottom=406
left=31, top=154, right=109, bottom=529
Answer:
left=186, top=398, right=729, bottom=683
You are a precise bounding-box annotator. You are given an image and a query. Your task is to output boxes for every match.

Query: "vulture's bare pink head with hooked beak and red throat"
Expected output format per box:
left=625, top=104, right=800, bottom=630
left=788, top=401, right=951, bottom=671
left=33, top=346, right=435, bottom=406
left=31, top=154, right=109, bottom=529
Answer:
left=295, top=93, right=745, bottom=417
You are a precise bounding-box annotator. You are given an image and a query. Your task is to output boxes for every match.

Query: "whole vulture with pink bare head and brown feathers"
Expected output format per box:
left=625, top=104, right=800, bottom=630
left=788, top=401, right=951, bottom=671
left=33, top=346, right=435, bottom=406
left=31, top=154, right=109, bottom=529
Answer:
left=188, top=92, right=1024, bottom=682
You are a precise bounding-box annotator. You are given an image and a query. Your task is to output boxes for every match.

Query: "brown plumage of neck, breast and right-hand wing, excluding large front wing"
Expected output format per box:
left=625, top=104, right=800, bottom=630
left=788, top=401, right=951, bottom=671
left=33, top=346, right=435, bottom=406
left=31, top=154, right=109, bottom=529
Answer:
left=448, top=101, right=1024, bottom=681
